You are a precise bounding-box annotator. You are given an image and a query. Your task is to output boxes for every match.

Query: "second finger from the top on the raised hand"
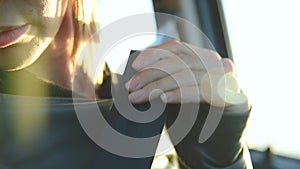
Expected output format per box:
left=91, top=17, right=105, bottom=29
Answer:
left=126, top=56, right=233, bottom=92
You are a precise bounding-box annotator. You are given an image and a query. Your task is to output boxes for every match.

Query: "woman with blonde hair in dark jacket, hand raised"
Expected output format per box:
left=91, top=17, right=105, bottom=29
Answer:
left=0, top=0, right=250, bottom=169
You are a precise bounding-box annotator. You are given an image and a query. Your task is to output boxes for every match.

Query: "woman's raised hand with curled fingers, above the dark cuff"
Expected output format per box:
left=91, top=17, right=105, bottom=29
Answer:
left=126, top=40, right=249, bottom=112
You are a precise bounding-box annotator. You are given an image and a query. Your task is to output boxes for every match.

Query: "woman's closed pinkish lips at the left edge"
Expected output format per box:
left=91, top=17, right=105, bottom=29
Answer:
left=0, top=24, right=29, bottom=48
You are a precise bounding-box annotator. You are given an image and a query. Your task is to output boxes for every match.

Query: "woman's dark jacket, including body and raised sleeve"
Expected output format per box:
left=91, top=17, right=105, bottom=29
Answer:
left=0, top=67, right=250, bottom=169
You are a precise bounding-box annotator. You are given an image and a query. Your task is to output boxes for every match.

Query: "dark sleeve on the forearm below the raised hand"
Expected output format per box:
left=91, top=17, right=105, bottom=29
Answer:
left=167, top=104, right=252, bottom=169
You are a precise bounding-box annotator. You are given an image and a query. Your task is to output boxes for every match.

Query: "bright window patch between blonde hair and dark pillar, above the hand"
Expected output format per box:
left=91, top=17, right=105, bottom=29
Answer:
left=99, top=0, right=156, bottom=74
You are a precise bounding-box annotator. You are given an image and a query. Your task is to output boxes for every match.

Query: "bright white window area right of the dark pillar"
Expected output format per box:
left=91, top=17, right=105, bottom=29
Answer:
left=222, top=0, right=300, bottom=158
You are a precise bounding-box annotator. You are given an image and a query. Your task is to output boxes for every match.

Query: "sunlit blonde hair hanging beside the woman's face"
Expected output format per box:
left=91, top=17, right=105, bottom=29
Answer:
left=71, top=0, right=103, bottom=83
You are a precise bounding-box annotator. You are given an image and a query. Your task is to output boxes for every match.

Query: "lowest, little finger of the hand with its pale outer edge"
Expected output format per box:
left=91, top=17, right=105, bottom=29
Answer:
left=160, top=73, right=247, bottom=107
